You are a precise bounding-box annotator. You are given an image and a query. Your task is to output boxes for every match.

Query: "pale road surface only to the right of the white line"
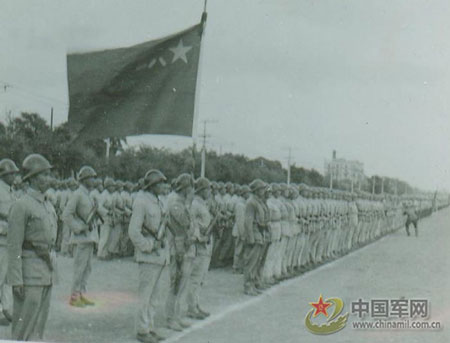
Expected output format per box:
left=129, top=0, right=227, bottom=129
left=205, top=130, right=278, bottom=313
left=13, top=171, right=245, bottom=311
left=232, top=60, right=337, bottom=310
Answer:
left=170, top=209, right=450, bottom=343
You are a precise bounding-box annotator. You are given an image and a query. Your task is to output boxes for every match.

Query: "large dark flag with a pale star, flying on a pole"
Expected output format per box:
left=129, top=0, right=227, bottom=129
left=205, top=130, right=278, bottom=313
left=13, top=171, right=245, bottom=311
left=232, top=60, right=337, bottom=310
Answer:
left=67, top=23, right=203, bottom=141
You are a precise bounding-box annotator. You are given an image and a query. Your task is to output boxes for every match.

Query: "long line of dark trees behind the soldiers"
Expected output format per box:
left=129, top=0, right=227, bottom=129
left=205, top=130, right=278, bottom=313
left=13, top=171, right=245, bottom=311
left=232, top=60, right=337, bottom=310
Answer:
left=0, top=112, right=414, bottom=194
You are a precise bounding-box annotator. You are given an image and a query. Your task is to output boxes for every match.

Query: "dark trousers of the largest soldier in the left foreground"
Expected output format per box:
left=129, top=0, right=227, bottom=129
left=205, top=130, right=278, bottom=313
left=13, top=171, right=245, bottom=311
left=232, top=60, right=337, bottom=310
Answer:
left=11, top=286, right=52, bottom=341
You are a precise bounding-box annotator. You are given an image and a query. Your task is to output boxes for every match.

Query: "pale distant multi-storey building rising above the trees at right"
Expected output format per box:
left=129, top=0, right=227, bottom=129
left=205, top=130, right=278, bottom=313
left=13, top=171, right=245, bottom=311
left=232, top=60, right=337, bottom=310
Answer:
left=324, top=150, right=366, bottom=184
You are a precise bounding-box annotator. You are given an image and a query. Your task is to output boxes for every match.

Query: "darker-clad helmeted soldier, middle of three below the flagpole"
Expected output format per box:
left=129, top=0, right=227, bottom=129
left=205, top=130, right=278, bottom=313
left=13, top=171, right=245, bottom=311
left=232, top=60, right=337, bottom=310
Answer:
left=167, top=174, right=196, bottom=331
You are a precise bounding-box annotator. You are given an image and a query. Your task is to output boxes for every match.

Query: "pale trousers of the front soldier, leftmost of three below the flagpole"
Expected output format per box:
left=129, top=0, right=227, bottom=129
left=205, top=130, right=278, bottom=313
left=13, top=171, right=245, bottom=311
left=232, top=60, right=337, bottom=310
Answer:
left=136, top=262, right=167, bottom=334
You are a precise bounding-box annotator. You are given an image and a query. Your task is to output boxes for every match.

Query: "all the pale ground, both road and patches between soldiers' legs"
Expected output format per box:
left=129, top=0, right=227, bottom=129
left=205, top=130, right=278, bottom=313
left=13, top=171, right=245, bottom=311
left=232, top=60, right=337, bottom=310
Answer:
left=0, top=209, right=450, bottom=343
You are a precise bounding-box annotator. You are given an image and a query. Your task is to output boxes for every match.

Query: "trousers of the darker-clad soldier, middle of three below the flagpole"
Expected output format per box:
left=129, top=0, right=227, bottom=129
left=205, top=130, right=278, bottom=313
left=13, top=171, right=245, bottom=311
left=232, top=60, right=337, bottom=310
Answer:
left=166, top=256, right=194, bottom=321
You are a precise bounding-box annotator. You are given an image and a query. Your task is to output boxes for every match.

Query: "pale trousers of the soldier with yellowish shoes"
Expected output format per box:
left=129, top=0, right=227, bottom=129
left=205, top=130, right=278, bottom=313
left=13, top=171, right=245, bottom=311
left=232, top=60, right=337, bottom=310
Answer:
left=72, top=243, right=94, bottom=295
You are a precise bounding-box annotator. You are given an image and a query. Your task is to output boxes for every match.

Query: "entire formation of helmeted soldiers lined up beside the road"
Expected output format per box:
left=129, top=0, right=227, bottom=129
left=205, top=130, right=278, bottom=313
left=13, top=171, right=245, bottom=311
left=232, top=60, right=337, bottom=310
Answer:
left=0, top=155, right=442, bottom=342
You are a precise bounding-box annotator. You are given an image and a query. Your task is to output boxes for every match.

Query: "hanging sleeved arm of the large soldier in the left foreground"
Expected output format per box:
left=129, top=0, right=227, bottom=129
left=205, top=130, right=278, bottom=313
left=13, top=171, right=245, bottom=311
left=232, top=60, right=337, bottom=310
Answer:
left=7, top=202, right=28, bottom=286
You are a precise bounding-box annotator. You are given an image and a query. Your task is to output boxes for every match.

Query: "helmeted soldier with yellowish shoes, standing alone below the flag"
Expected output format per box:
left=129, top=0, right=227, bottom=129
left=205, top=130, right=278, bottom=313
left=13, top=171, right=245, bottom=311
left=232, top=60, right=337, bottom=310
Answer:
left=62, top=166, right=99, bottom=307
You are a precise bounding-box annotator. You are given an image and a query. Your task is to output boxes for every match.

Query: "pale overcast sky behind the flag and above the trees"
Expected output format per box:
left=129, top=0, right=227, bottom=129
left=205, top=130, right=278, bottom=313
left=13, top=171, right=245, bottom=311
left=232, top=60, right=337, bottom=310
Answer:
left=0, top=0, right=450, bottom=190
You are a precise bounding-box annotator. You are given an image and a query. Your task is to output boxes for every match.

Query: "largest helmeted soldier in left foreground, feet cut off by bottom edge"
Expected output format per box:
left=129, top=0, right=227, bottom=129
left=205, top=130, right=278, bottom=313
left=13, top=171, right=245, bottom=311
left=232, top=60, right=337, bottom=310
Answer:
left=7, top=154, right=57, bottom=341
